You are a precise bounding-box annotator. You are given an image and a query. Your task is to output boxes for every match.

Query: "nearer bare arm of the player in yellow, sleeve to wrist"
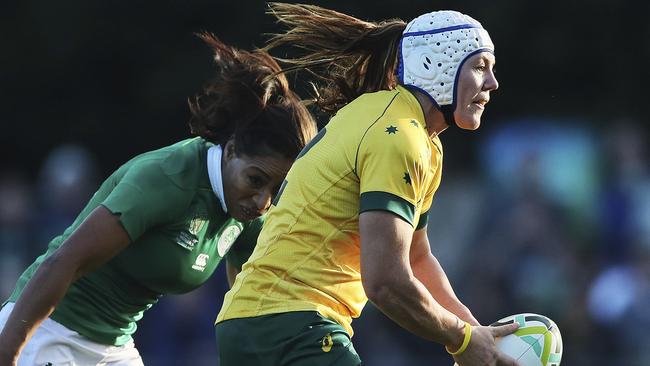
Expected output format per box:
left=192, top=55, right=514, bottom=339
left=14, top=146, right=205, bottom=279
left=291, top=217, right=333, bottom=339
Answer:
left=359, top=211, right=465, bottom=349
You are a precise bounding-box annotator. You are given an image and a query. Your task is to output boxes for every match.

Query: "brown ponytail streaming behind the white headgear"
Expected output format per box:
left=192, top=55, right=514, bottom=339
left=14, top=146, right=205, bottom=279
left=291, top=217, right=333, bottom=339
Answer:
left=264, top=2, right=406, bottom=113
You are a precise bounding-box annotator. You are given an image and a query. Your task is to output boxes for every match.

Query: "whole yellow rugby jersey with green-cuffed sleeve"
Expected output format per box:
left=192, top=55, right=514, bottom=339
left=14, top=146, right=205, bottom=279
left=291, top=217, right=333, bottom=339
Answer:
left=217, top=87, right=442, bottom=335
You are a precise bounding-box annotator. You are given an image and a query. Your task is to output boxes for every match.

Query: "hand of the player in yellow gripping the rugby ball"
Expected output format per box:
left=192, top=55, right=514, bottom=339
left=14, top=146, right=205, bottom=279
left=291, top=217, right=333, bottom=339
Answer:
left=454, top=323, right=519, bottom=366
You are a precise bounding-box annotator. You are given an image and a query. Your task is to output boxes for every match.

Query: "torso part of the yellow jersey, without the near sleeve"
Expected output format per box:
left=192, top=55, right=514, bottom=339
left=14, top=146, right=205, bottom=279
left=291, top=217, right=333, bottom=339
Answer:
left=220, top=89, right=440, bottom=328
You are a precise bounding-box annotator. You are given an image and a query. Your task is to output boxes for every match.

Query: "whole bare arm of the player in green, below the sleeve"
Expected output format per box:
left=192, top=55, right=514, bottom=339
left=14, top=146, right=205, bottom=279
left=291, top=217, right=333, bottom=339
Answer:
left=0, top=206, right=130, bottom=365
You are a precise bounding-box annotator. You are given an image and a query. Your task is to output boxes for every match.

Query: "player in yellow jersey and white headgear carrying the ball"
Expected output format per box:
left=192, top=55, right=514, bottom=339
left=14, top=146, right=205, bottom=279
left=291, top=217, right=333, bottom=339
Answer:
left=216, top=3, right=517, bottom=366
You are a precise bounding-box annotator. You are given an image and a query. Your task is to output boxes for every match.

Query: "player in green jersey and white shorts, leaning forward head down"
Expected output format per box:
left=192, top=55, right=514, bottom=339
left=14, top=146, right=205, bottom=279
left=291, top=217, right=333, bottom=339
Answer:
left=0, top=34, right=316, bottom=366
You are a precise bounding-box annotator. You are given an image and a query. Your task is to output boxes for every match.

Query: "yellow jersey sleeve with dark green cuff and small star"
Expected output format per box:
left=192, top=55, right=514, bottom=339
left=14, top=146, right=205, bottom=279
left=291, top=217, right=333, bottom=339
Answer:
left=356, top=119, right=430, bottom=227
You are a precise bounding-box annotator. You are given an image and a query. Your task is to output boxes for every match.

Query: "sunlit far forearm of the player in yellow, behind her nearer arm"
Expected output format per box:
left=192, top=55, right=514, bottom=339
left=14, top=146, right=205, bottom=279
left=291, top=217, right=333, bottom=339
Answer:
left=411, top=254, right=480, bottom=325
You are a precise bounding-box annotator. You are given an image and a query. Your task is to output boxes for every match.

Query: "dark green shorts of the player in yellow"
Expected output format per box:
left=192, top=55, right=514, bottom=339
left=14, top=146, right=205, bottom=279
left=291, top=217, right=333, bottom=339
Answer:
left=215, top=311, right=361, bottom=366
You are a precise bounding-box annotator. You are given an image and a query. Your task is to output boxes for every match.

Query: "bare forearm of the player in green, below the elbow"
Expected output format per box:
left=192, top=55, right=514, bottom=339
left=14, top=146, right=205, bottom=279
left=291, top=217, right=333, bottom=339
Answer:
left=0, top=258, right=74, bottom=364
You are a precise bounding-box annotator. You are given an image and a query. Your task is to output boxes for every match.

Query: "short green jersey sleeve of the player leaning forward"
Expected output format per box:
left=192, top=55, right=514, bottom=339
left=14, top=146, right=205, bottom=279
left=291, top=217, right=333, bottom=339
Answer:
left=101, top=161, right=191, bottom=241
